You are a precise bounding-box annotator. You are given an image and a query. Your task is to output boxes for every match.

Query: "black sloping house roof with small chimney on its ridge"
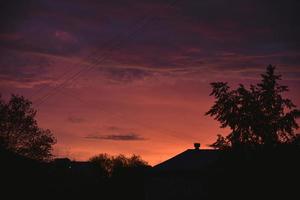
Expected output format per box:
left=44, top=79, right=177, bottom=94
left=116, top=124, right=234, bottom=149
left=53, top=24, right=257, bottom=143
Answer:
left=154, top=143, right=220, bottom=171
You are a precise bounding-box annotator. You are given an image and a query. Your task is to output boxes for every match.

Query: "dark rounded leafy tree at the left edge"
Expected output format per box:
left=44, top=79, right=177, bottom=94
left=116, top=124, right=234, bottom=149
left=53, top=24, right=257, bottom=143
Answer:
left=0, top=95, right=56, bottom=160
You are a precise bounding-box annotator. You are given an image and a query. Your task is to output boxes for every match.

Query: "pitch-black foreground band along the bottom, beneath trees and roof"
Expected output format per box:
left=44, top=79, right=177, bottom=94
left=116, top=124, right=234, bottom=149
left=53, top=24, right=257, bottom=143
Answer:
left=0, top=147, right=300, bottom=199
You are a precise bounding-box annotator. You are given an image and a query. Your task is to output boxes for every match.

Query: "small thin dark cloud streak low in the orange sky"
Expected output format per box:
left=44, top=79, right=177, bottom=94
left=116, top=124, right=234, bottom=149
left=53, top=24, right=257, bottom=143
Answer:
left=85, top=133, right=146, bottom=141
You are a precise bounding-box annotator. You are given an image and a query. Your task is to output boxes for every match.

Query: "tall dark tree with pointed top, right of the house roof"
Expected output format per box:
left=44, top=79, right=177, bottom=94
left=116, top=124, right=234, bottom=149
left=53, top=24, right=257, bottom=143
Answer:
left=206, top=65, right=300, bottom=149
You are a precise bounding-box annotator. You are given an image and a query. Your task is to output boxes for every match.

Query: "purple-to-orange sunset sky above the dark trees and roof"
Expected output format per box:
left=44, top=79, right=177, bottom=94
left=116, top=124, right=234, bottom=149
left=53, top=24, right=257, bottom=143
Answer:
left=0, top=0, right=300, bottom=165
